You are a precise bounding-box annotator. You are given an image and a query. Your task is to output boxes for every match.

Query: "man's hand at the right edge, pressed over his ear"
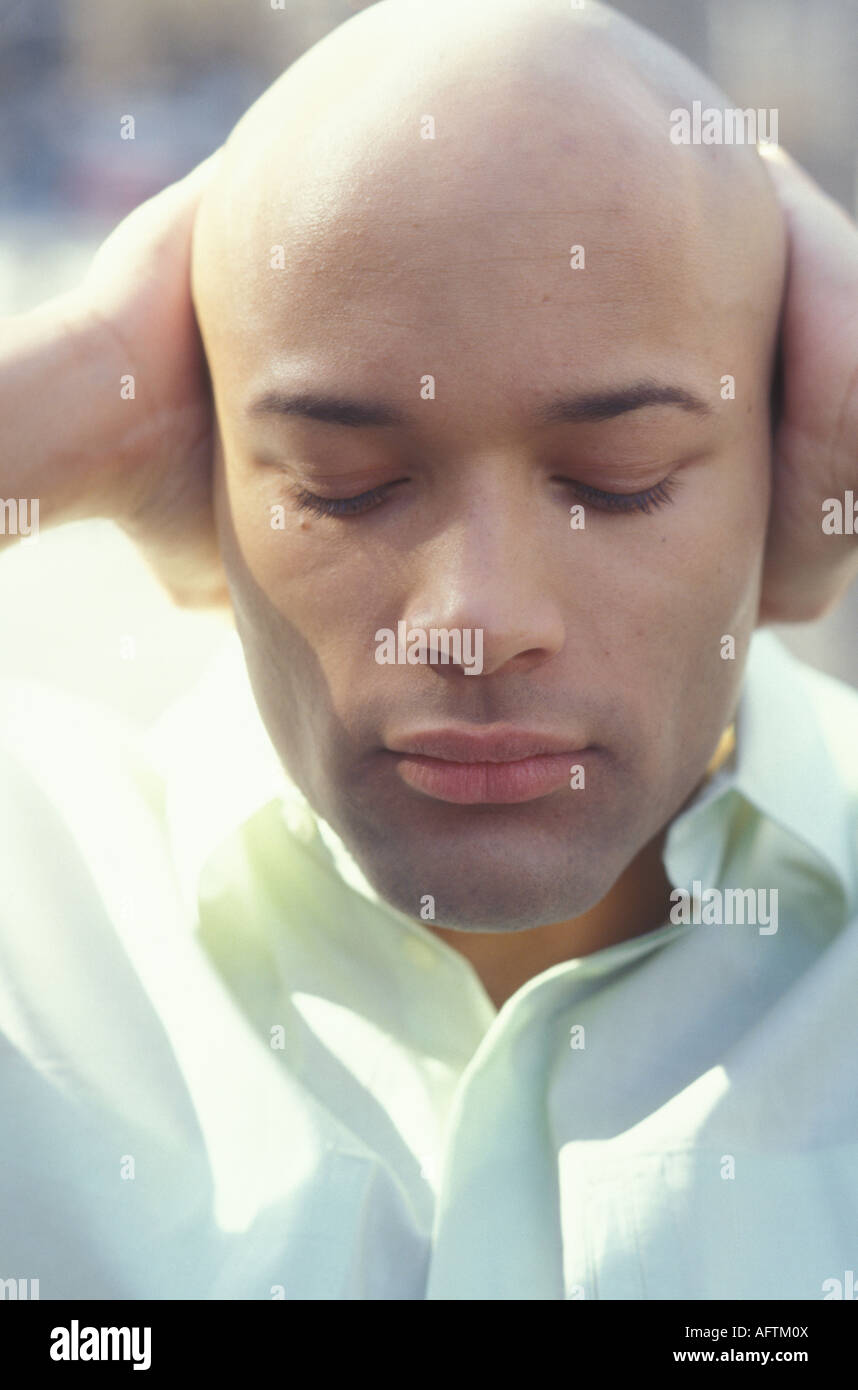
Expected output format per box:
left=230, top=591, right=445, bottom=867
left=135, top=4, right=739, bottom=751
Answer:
left=759, top=146, right=858, bottom=623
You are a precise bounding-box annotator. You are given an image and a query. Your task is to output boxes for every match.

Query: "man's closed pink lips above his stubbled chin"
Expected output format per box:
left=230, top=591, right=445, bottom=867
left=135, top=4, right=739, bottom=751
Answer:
left=387, top=726, right=594, bottom=806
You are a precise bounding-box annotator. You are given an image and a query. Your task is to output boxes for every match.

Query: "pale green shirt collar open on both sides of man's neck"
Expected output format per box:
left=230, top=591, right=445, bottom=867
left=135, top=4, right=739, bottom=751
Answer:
left=149, top=630, right=854, bottom=920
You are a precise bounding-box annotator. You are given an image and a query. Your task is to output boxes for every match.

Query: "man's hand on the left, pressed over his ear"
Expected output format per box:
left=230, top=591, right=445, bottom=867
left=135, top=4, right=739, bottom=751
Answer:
left=78, top=152, right=229, bottom=607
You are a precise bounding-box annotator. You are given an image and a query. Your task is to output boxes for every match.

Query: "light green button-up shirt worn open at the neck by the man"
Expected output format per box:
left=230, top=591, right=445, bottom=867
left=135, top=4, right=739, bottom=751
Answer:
left=0, top=632, right=858, bottom=1300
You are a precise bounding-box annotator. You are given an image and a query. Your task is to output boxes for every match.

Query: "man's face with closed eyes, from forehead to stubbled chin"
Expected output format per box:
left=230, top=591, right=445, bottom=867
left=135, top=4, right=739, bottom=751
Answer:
left=194, top=51, right=777, bottom=930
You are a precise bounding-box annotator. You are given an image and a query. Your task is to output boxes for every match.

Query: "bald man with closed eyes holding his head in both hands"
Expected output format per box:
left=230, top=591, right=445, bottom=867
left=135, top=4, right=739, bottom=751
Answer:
left=0, top=0, right=858, bottom=1300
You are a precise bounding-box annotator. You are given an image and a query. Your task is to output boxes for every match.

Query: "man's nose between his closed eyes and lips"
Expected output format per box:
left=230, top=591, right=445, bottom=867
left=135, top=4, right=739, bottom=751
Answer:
left=406, top=477, right=565, bottom=680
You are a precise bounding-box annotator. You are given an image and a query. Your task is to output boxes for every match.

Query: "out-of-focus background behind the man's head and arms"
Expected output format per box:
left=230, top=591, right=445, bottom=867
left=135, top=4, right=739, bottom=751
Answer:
left=0, top=0, right=858, bottom=720
